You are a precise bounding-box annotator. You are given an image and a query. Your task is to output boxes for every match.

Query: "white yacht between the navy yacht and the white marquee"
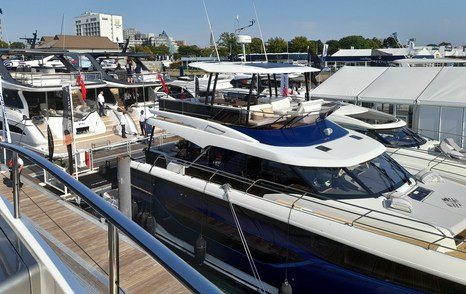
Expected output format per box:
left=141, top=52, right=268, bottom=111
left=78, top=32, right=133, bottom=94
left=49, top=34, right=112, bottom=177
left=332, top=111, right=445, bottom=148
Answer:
left=329, top=102, right=466, bottom=184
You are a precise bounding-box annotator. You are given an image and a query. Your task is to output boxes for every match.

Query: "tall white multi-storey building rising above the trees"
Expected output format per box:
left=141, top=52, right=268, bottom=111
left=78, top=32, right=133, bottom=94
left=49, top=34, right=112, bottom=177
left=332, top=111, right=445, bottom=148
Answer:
left=74, top=12, right=124, bottom=43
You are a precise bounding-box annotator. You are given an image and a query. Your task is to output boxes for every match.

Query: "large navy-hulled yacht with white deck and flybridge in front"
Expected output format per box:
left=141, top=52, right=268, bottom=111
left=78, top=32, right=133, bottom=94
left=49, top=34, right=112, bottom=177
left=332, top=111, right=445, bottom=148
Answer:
left=131, top=60, right=466, bottom=293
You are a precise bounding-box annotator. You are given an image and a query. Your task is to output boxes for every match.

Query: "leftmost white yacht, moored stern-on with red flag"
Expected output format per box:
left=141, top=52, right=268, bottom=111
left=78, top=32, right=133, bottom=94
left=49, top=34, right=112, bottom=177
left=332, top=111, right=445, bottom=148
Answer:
left=0, top=49, right=118, bottom=157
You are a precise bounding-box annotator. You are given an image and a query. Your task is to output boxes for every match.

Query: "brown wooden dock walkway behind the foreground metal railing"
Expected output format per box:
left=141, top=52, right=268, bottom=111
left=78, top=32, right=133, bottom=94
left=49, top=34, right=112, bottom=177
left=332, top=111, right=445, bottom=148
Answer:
left=0, top=168, right=190, bottom=293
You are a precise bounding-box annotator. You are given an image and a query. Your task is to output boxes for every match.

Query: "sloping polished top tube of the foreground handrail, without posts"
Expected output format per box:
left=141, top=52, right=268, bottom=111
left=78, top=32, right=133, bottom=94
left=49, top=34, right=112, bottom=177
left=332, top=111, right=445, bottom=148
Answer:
left=0, top=142, right=221, bottom=293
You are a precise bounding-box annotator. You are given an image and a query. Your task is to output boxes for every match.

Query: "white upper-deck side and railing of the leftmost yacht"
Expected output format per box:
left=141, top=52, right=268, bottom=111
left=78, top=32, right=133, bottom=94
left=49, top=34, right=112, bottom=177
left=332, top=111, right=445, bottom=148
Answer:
left=10, top=68, right=102, bottom=87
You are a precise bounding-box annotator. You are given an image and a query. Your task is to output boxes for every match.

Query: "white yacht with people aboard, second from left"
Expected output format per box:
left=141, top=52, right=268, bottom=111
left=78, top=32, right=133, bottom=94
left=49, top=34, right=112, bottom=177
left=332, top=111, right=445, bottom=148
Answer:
left=67, top=52, right=170, bottom=134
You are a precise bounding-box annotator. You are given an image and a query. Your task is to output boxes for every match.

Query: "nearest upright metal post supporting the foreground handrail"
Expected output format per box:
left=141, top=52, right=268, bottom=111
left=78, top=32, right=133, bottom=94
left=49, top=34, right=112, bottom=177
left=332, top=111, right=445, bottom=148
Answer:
left=108, top=222, right=120, bottom=294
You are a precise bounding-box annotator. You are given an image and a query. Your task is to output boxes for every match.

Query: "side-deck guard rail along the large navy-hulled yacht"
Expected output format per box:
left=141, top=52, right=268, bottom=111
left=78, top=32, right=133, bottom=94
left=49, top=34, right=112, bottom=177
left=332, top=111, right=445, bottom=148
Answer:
left=152, top=152, right=463, bottom=252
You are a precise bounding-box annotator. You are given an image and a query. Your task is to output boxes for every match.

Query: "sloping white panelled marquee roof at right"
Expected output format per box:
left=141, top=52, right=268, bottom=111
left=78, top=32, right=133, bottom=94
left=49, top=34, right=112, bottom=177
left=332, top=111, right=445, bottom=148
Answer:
left=311, top=66, right=466, bottom=107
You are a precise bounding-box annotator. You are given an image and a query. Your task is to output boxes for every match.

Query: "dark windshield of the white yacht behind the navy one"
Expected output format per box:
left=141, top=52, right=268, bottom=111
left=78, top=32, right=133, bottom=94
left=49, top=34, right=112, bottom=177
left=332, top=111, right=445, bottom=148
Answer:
left=367, top=127, right=426, bottom=147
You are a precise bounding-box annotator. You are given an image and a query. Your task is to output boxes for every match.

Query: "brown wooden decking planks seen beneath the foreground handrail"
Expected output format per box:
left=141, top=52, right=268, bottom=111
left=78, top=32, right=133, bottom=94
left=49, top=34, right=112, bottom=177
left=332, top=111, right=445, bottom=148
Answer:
left=0, top=167, right=190, bottom=293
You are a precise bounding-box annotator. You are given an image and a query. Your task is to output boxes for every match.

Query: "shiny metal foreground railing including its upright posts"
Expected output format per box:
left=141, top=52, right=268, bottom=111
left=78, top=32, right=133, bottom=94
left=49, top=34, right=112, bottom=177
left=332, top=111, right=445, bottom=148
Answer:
left=0, top=142, right=220, bottom=293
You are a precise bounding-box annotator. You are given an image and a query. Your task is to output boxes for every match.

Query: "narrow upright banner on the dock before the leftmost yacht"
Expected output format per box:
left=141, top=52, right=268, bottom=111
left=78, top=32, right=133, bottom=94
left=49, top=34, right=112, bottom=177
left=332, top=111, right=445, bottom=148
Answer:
left=62, top=85, right=73, bottom=175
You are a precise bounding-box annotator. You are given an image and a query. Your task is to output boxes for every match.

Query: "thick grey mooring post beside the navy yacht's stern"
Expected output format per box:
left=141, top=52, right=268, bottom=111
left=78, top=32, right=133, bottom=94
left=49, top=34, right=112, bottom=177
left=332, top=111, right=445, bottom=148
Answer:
left=117, top=154, right=132, bottom=219
